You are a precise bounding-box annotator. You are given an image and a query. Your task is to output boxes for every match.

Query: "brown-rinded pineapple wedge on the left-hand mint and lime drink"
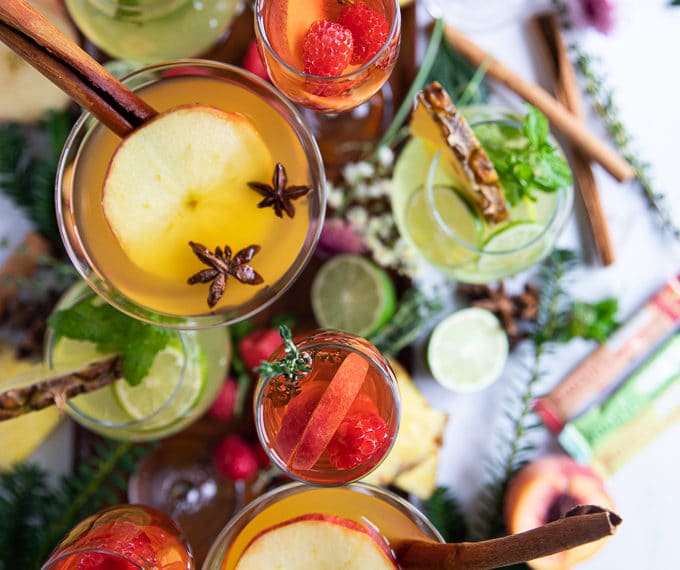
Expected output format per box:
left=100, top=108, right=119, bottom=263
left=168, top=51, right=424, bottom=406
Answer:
left=0, top=355, right=123, bottom=421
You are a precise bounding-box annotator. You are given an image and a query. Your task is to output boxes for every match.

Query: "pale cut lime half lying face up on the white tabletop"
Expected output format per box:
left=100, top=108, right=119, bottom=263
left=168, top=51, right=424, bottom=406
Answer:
left=427, top=307, right=508, bottom=392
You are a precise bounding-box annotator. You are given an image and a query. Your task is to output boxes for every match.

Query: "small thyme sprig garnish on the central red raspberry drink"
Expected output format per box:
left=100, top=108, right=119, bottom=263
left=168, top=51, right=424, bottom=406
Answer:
left=255, top=325, right=312, bottom=407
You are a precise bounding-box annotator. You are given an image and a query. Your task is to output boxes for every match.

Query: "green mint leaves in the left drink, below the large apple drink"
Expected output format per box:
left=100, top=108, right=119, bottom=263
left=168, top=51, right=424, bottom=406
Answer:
left=47, top=298, right=177, bottom=386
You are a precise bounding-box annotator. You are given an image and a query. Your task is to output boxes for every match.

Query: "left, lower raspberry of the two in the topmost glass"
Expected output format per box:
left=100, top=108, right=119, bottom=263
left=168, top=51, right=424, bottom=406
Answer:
left=302, top=20, right=354, bottom=77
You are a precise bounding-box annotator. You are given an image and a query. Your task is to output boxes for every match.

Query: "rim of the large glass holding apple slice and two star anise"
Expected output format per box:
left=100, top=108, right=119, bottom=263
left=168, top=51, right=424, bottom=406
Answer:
left=55, top=58, right=326, bottom=330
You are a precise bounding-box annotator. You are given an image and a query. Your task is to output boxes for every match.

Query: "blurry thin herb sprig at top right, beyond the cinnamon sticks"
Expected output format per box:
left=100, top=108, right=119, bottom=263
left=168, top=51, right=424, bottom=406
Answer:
left=552, top=0, right=680, bottom=240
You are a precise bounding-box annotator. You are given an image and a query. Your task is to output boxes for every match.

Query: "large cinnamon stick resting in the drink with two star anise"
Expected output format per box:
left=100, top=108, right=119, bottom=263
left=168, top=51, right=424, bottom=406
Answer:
left=0, top=0, right=156, bottom=136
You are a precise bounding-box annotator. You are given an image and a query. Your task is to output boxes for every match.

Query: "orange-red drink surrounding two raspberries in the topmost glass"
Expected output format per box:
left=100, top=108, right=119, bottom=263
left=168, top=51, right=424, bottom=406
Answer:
left=255, top=0, right=401, bottom=113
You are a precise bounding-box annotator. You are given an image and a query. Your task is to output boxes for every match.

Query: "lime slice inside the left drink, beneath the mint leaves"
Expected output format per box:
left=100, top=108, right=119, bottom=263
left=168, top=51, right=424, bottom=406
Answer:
left=113, top=332, right=207, bottom=422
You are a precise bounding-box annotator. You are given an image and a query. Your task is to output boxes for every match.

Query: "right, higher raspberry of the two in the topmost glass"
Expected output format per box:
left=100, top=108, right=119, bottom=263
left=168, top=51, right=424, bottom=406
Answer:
left=338, top=4, right=390, bottom=65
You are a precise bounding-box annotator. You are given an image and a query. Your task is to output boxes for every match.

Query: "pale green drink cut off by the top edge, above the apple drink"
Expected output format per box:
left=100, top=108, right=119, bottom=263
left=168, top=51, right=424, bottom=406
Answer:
left=66, top=0, right=239, bottom=65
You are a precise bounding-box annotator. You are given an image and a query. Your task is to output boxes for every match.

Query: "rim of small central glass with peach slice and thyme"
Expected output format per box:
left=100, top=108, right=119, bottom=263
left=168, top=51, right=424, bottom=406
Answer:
left=253, top=329, right=402, bottom=488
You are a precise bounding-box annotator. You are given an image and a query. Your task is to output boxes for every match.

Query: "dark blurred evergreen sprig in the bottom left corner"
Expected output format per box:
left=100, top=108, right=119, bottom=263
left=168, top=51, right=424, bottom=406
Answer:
left=0, top=440, right=153, bottom=570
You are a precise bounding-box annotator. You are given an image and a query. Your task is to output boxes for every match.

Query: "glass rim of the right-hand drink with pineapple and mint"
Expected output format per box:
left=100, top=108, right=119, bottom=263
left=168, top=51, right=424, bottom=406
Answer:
left=423, top=105, right=573, bottom=256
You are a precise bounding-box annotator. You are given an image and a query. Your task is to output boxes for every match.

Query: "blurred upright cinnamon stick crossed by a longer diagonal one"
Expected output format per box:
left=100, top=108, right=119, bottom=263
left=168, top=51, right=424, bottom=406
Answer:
left=531, top=12, right=615, bottom=266
